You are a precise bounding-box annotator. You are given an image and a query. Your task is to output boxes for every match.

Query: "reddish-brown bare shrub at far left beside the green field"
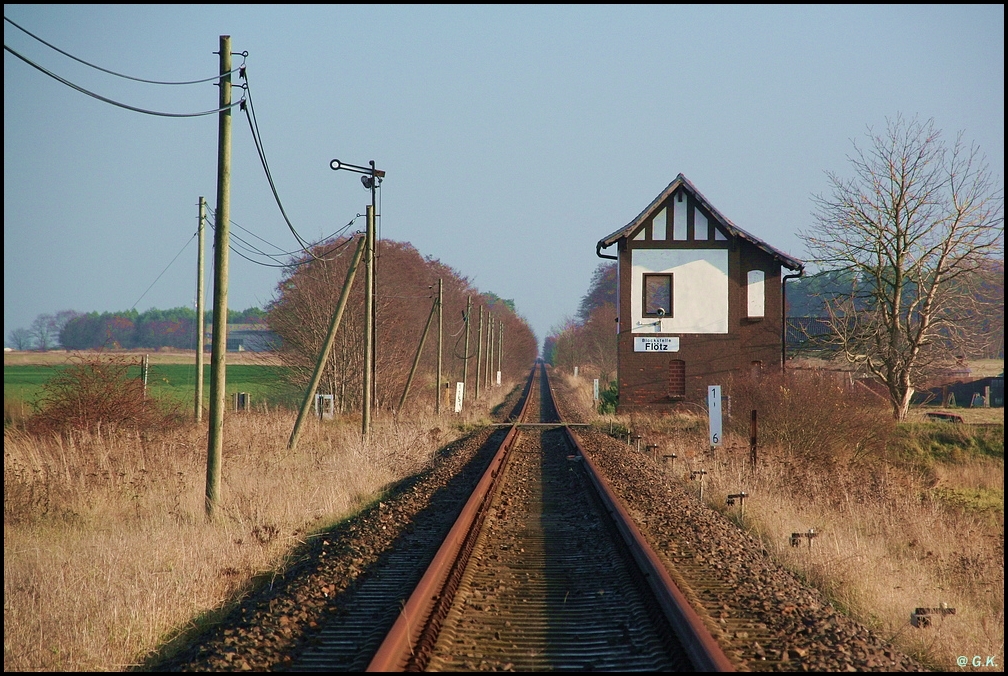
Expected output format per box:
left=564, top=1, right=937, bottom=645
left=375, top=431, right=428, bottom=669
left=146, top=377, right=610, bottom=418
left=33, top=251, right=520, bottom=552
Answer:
left=25, top=355, right=181, bottom=436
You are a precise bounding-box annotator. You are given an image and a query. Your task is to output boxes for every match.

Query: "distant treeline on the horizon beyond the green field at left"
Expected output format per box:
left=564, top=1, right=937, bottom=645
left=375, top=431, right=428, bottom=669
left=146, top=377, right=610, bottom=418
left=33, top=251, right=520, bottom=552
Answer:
left=59, top=307, right=266, bottom=350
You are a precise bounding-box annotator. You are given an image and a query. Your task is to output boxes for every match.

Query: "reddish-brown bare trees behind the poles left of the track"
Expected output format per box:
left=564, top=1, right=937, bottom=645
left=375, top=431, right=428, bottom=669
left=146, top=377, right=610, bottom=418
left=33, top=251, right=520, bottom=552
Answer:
left=267, top=239, right=538, bottom=411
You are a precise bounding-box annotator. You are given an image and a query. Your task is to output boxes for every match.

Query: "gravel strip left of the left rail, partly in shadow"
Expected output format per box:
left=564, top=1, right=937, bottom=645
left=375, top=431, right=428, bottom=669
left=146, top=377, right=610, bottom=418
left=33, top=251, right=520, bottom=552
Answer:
left=145, top=428, right=506, bottom=671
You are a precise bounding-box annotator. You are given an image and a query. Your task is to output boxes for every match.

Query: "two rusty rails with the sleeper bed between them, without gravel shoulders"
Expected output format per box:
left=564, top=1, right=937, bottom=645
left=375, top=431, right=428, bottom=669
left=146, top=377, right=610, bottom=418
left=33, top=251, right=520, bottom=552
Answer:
left=362, top=366, right=732, bottom=671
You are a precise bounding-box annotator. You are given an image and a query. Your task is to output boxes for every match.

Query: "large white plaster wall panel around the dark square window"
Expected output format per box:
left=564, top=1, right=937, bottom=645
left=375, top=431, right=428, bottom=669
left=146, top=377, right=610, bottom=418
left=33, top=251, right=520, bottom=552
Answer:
left=630, top=249, right=728, bottom=333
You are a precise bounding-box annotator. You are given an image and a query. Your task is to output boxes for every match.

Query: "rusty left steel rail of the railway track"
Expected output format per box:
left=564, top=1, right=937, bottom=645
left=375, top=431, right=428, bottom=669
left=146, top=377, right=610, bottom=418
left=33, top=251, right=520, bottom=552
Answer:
left=367, top=365, right=541, bottom=671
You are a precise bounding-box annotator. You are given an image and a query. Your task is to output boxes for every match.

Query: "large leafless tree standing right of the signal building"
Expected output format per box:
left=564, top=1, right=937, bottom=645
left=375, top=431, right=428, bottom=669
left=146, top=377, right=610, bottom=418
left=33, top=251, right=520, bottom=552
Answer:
left=801, top=117, right=1004, bottom=420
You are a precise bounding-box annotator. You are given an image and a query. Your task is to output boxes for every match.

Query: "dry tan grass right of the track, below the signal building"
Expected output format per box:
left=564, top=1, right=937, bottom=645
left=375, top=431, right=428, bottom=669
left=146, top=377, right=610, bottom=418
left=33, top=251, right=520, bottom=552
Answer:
left=560, top=377, right=1004, bottom=670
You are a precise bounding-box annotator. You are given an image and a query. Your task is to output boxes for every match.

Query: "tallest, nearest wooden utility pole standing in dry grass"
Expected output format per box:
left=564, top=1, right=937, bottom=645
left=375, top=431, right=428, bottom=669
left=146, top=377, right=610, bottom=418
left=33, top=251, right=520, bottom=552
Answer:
left=205, top=35, right=231, bottom=519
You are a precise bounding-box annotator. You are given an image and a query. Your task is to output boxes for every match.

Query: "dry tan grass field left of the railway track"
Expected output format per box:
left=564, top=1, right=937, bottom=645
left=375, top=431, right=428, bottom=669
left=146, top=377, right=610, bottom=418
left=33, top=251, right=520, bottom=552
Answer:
left=4, top=380, right=509, bottom=671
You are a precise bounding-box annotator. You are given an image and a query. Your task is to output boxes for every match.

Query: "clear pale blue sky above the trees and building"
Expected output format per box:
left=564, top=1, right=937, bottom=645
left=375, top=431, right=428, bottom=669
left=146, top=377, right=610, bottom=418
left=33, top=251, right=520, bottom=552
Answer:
left=3, top=4, right=1005, bottom=348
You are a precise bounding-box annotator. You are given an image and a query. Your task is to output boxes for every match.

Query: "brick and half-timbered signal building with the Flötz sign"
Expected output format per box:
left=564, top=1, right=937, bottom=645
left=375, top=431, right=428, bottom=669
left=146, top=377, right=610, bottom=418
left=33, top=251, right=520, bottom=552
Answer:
left=596, top=173, right=803, bottom=411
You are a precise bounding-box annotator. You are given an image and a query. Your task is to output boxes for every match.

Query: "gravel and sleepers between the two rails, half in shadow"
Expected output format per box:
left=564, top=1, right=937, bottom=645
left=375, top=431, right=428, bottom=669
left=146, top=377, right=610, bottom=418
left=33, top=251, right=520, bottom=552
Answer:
left=426, top=429, right=689, bottom=671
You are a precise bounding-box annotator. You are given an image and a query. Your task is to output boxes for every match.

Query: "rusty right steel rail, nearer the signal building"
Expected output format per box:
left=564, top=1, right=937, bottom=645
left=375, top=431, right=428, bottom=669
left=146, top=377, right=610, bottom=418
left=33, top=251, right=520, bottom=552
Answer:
left=543, top=370, right=735, bottom=671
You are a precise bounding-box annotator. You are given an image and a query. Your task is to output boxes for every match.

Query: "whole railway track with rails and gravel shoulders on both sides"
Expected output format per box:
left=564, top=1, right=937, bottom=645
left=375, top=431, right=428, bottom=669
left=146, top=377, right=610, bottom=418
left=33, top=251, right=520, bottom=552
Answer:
left=155, top=367, right=921, bottom=671
